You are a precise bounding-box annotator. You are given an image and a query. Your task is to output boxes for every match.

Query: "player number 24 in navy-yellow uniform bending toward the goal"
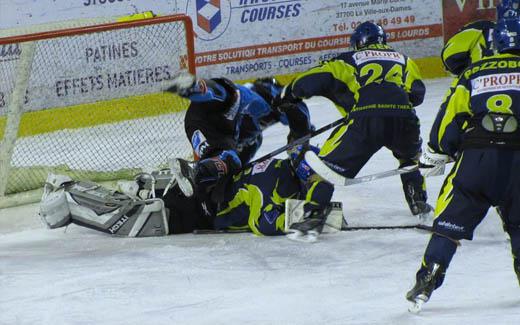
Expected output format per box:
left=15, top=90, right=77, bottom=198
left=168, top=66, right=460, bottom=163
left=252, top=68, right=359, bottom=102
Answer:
left=283, top=22, right=432, bottom=240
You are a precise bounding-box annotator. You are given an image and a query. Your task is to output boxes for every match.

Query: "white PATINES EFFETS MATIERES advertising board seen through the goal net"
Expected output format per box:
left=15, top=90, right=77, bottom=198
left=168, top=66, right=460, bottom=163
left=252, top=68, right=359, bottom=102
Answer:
left=0, top=22, right=187, bottom=116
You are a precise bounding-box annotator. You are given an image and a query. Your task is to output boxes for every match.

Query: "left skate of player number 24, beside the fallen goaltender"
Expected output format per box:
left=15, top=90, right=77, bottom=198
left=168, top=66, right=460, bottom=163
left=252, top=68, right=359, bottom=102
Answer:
left=287, top=205, right=331, bottom=243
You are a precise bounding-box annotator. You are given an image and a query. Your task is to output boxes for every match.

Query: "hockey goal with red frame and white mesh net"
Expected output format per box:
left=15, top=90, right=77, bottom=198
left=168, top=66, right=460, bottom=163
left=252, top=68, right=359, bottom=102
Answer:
left=0, top=15, right=195, bottom=205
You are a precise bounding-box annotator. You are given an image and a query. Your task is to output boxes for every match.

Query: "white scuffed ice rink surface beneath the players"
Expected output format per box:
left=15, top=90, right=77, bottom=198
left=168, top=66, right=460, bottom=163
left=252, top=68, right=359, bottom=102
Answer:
left=0, top=79, right=520, bottom=325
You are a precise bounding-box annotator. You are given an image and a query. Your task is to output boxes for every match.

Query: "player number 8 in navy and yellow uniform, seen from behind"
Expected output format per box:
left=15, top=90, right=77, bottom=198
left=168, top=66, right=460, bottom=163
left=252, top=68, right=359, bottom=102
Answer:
left=406, top=15, right=520, bottom=311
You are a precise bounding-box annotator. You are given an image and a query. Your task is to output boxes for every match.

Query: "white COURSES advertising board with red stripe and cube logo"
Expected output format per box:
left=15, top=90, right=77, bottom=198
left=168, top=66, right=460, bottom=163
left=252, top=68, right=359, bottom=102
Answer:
left=176, top=0, right=442, bottom=79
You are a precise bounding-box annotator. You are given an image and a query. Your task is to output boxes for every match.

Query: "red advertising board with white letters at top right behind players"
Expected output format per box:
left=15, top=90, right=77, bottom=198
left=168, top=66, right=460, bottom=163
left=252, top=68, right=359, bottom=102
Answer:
left=443, top=0, right=501, bottom=40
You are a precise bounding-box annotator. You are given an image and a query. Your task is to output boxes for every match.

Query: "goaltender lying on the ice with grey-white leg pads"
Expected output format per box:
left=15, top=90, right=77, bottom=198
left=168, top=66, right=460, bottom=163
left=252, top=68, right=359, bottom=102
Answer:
left=40, top=153, right=343, bottom=237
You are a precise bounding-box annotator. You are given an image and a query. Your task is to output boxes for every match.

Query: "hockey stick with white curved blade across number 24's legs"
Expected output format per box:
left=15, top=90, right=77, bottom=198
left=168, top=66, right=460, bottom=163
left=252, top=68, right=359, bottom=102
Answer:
left=305, top=150, right=419, bottom=186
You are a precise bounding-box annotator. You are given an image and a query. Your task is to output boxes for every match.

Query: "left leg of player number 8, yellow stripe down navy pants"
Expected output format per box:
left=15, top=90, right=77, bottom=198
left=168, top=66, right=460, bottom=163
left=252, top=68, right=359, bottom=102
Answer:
left=406, top=154, right=494, bottom=303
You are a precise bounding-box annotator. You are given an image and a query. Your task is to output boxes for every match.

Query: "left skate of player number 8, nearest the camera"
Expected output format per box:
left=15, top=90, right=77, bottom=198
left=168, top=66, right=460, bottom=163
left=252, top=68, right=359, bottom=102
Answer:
left=406, top=263, right=443, bottom=314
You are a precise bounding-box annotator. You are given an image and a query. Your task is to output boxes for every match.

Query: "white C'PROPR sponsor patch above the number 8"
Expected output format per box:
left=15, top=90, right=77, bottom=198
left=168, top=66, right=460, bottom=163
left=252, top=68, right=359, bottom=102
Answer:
left=471, top=73, right=520, bottom=96
